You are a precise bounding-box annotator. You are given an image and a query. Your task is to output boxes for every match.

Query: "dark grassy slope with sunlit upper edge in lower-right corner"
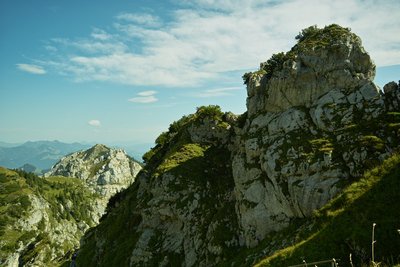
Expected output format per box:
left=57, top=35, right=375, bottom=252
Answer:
left=252, top=155, right=400, bottom=266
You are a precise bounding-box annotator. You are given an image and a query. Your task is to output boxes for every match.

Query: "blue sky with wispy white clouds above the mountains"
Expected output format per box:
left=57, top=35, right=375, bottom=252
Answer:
left=0, top=0, right=400, bottom=149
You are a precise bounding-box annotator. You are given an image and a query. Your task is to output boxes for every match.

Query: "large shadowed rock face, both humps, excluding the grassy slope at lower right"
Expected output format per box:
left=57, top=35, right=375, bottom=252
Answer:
left=76, top=26, right=400, bottom=266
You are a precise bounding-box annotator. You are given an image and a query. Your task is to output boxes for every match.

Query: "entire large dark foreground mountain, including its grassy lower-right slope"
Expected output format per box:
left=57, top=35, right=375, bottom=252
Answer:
left=77, top=24, right=400, bottom=266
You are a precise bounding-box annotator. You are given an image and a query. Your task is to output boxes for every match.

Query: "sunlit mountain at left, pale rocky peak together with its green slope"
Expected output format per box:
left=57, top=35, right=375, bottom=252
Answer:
left=0, top=145, right=142, bottom=266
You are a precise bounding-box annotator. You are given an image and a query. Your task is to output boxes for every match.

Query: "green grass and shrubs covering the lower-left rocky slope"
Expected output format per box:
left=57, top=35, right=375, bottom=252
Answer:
left=0, top=167, right=96, bottom=266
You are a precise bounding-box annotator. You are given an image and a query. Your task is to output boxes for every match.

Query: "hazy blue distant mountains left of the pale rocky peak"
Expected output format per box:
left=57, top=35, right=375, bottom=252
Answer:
left=0, top=141, right=90, bottom=170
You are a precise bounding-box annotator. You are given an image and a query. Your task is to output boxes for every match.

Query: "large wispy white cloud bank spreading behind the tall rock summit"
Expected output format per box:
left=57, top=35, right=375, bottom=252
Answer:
left=42, top=0, right=400, bottom=87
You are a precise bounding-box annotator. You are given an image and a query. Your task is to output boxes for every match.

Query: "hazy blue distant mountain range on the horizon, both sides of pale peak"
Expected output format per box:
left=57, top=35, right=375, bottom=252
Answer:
left=0, top=140, right=151, bottom=174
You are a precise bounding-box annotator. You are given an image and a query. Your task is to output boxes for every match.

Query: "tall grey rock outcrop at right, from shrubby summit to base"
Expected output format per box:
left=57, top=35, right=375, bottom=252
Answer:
left=232, top=26, right=399, bottom=246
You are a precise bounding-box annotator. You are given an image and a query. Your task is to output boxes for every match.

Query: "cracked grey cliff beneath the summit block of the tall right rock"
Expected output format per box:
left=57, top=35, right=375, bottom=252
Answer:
left=232, top=83, right=399, bottom=246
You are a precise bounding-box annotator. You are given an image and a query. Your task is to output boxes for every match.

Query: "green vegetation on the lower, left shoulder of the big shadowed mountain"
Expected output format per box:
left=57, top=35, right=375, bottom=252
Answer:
left=78, top=106, right=237, bottom=266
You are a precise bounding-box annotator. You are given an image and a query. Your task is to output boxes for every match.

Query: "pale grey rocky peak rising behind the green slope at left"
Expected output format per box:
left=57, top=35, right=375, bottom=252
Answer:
left=45, top=144, right=142, bottom=200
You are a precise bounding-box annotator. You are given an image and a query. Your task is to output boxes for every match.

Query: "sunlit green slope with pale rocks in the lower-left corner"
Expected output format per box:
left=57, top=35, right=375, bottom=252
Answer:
left=0, top=167, right=104, bottom=267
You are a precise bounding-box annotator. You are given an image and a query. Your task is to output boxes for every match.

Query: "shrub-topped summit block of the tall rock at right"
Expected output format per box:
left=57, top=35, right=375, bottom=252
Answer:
left=243, top=24, right=377, bottom=116
